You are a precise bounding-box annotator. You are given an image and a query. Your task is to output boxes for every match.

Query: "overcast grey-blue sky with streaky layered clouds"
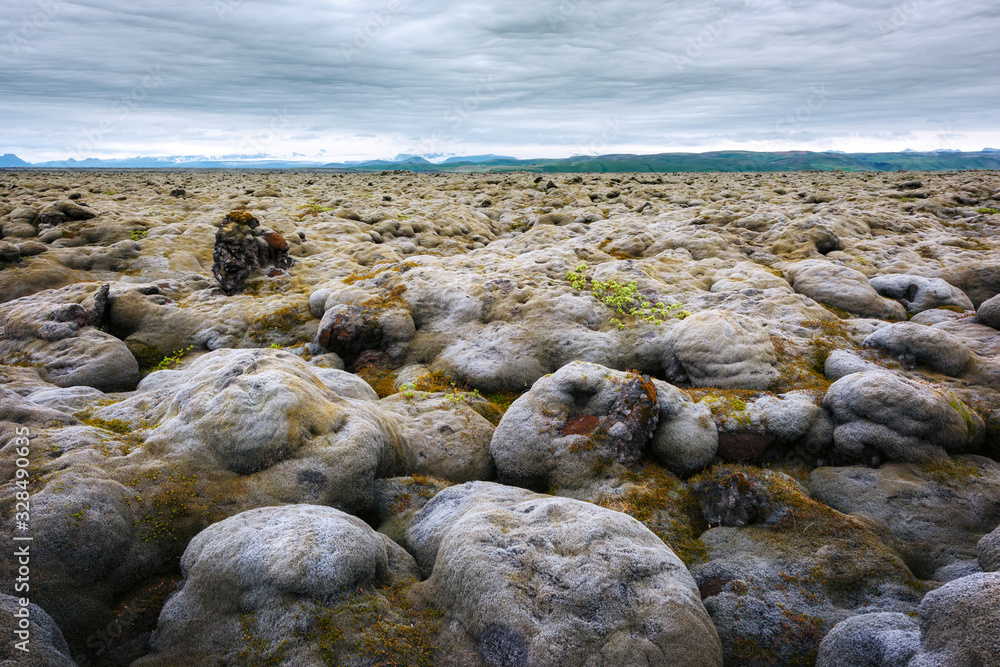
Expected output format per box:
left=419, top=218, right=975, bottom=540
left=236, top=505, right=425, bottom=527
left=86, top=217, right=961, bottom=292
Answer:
left=0, top=0, right=1000, bottom=162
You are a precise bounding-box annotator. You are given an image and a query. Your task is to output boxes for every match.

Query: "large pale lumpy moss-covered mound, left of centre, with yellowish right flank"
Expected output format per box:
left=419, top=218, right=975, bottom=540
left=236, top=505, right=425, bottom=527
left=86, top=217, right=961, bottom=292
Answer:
left=102, top=350, right=403, bottom=498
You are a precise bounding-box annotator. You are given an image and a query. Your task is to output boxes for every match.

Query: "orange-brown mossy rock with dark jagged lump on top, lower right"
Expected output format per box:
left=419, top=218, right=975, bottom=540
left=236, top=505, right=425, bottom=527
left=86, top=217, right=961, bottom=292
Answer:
left=692, top=466, right=922, bottom=665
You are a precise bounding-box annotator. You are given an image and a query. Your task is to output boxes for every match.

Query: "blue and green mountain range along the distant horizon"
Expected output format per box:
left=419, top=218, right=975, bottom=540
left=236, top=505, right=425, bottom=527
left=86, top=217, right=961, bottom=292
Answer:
left=0, top=148, right=1000, bottom=173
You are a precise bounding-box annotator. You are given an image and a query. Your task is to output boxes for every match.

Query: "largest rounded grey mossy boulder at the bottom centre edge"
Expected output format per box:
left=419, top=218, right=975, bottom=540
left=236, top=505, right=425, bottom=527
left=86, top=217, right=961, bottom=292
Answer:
left=406, top=482, right=722, bottom=666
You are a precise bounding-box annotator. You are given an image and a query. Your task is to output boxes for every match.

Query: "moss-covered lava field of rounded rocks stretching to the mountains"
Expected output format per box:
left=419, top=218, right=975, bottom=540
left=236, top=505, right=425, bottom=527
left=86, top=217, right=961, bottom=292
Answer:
left=0, top=171, right=1000, bottom=667
